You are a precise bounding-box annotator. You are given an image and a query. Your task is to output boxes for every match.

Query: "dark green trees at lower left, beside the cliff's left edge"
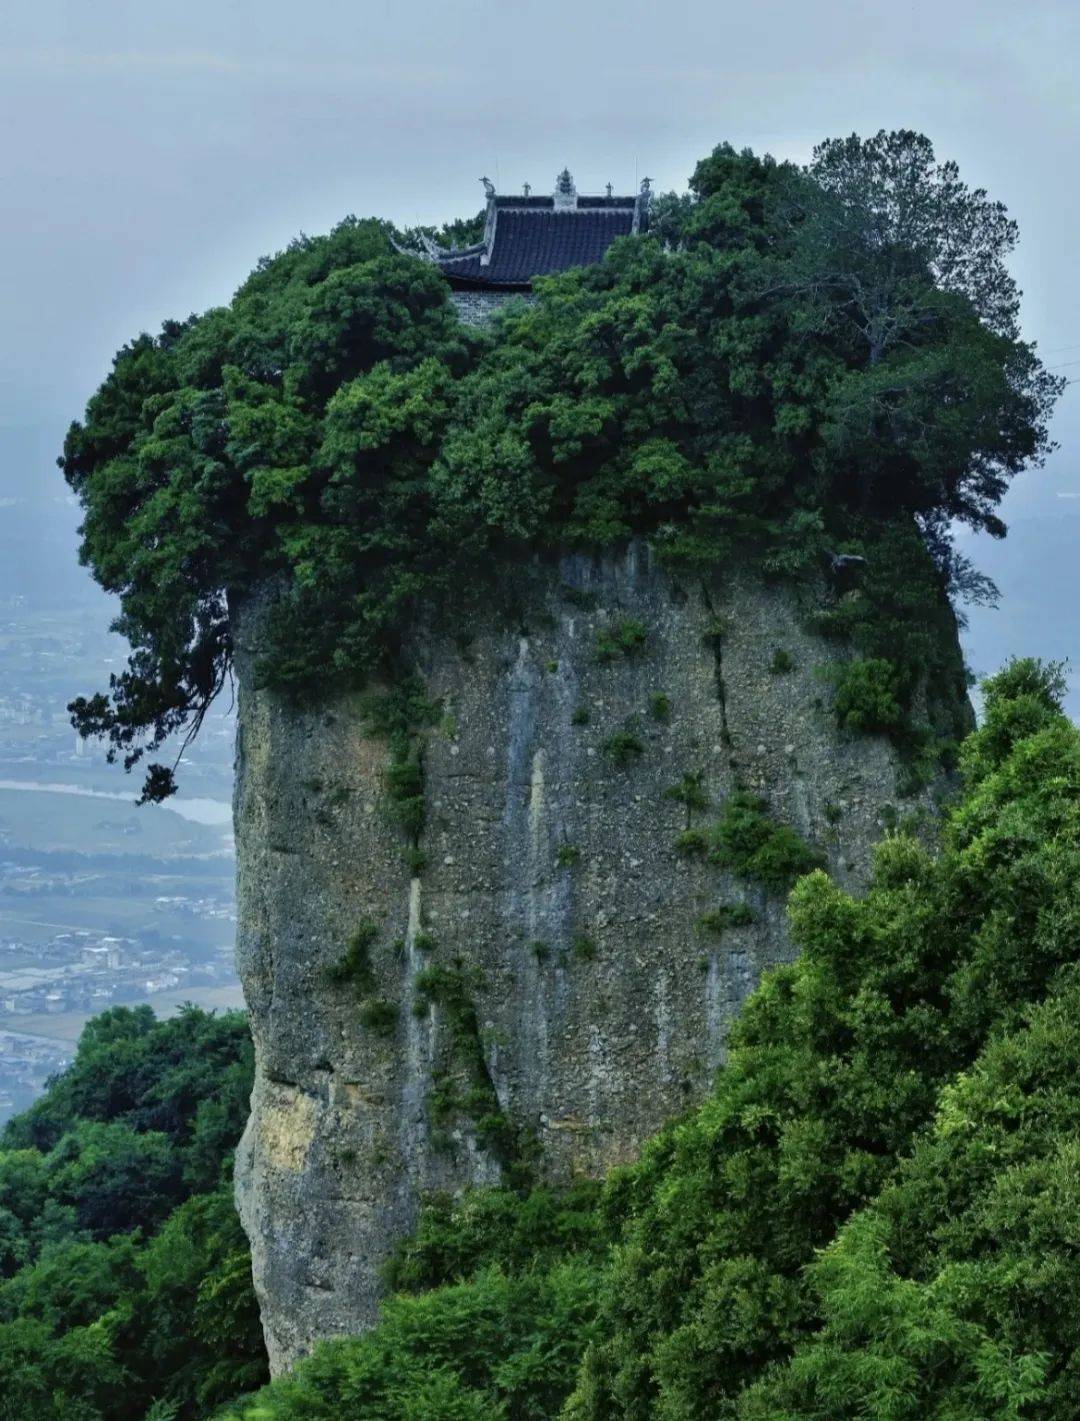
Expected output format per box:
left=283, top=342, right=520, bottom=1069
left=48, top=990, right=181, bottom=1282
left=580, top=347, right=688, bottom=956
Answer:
left=0, top=1006, right=266, bottom=1421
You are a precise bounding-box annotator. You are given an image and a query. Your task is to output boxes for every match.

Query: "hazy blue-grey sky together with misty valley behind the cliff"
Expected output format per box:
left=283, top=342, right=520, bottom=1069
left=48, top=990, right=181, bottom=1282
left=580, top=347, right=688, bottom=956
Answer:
left=0, top=0, right=1080, bottom=1114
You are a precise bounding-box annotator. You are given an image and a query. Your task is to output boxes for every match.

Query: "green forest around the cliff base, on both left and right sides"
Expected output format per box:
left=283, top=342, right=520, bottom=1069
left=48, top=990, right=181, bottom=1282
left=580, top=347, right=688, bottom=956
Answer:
left=0, top=662, right=1080, bottom=1421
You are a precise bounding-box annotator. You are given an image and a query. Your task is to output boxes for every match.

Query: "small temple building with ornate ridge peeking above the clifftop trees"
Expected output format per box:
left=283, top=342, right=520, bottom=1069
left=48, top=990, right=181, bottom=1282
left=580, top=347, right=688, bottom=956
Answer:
left=423, top=168, right=651, bottom=325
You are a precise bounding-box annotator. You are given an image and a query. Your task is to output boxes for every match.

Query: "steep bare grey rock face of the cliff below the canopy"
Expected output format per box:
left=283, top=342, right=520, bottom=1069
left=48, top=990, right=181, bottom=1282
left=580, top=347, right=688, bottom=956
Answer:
left=236, top=546, right=960, bottom=1368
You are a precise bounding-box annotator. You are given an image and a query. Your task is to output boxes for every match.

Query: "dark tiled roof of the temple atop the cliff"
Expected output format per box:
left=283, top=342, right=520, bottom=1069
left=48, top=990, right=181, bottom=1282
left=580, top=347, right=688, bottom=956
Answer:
left=439, top=207, right=634, bottom=288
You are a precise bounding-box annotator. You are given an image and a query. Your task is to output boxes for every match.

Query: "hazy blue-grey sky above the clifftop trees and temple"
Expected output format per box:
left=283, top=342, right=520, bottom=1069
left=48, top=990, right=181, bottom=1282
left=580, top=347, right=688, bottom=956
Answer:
left=0, top=0, right=1080, bottom=522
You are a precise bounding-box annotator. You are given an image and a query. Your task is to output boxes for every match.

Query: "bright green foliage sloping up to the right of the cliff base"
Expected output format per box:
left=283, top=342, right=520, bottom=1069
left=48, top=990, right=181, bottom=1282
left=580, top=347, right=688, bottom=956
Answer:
left=218, top=662, right=1080, bottom=1421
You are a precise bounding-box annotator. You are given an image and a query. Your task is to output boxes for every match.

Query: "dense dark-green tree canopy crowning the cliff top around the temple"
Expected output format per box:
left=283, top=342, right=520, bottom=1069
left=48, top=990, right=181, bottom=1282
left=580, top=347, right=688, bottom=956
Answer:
left=61, top=132, right=1059, bottom=797
